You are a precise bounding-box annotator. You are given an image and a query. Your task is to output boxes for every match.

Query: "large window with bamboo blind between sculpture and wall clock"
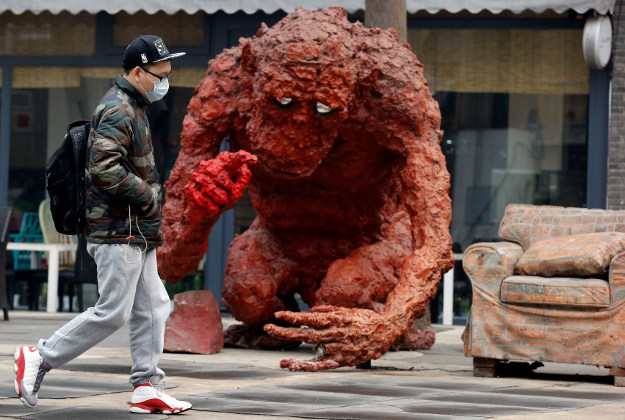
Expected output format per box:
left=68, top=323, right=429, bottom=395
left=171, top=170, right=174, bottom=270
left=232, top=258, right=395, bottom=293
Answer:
left=409, top=29, right=589, bottom=323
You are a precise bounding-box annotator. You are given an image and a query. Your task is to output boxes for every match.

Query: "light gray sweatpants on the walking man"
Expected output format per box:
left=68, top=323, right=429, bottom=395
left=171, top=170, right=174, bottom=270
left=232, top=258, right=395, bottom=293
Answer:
left=38, top=243, right=170, bottom=386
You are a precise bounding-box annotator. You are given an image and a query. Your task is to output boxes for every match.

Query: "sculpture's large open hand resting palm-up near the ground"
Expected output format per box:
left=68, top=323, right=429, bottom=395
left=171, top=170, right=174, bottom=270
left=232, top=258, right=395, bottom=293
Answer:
left=264, top=305, right=401, bottom=372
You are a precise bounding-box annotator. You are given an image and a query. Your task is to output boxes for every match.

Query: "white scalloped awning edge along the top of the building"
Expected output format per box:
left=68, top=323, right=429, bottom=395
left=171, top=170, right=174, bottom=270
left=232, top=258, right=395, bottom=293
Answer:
left=0, top=0, right=616, bottom=14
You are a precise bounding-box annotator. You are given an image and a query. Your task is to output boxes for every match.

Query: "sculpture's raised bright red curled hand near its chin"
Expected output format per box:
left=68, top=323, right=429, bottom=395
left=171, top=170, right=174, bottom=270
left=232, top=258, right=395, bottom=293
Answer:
left=184, top=150, right=257, bottom=223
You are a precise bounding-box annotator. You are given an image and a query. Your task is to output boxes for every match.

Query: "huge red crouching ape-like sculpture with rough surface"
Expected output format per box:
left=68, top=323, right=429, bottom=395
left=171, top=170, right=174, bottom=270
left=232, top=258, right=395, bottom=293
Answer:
left=158, top=8, right=453, bottom=371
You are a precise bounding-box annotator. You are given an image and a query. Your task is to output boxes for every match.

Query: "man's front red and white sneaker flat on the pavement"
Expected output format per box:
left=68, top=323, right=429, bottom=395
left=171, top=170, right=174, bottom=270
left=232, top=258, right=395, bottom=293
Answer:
left=130, top=381, right=191, bottom=414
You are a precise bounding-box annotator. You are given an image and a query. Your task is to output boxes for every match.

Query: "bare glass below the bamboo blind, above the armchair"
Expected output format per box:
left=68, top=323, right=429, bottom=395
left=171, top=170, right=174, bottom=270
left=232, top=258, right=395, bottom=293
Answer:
left=435, top=92, right=588, bottom=250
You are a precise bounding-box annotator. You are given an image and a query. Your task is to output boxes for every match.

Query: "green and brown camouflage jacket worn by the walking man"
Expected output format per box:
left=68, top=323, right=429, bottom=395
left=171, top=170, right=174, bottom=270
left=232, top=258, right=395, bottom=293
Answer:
left=85, top=76, right=163, bottom=247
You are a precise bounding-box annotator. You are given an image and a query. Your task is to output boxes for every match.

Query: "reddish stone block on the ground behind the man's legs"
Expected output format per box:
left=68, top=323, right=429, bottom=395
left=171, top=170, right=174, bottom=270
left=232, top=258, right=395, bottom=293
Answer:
left=164, top=290, right=224, bottom=354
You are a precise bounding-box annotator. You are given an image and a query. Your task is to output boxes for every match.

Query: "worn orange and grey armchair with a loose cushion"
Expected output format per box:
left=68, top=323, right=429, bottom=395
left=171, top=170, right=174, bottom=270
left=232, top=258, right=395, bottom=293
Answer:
left=463, top=204, right=625, bottom=386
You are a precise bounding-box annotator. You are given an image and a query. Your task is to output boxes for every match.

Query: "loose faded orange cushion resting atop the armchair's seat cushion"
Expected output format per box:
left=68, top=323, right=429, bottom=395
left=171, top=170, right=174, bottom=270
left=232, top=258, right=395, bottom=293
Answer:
left=516, top=232, right=625, bottom=277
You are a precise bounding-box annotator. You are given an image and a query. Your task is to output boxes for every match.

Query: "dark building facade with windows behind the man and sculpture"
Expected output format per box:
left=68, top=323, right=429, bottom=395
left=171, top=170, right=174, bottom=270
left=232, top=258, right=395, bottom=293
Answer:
left=0, top=0, right=625, bottom=316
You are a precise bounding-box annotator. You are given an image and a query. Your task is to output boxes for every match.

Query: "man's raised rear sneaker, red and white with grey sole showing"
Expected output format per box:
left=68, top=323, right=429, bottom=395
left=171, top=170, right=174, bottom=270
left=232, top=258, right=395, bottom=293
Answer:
left=13, top=346, right=50, bottom=408
